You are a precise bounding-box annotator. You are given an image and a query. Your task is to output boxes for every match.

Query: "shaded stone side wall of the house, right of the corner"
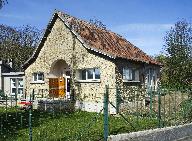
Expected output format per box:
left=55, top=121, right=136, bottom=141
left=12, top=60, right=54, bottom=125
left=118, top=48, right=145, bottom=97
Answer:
left=114, top=59, right=160, bottom=113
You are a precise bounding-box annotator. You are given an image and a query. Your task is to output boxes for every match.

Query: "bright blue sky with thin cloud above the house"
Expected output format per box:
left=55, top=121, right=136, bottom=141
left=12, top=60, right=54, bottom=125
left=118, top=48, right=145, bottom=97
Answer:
left=0, top=0, right=192, bottom=55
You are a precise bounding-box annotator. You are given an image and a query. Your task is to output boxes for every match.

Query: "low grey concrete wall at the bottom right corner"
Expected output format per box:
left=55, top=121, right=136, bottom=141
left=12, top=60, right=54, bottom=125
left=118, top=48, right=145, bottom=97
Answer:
left=108, top=123, right=192, bottom=141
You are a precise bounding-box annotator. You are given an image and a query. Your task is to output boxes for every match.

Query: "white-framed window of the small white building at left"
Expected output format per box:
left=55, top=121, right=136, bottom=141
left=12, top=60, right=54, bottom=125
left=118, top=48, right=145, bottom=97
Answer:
left=11, top=78, right=23, bottom=95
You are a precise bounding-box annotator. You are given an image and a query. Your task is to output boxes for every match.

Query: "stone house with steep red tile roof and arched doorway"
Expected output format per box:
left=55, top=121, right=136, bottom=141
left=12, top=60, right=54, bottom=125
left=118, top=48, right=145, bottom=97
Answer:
left=23, top=11, right=160, bottom=113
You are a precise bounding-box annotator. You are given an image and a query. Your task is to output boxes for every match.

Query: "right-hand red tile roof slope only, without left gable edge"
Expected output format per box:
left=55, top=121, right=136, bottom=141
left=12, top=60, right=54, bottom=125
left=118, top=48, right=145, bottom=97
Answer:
left=56, top=11, right=160, bottom=65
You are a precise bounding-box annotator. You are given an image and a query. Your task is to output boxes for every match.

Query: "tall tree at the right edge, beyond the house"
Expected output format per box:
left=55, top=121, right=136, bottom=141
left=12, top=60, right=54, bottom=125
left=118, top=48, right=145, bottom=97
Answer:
left=165, top=21, right=192, bottom=85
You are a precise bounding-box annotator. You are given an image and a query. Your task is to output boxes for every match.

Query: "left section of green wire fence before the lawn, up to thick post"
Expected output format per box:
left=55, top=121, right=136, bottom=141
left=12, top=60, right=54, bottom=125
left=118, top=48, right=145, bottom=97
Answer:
left=0, top=91, right=106, bottom=141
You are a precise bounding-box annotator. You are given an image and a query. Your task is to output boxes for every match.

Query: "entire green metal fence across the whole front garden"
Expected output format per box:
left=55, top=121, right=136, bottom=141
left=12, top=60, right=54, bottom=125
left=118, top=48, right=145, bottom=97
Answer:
left=0, top=86, right=192, bottom=141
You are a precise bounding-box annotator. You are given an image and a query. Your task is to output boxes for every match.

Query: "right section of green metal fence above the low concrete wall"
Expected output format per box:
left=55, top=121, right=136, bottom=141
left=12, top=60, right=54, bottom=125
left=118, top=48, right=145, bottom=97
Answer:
left=103, top=86, right=192, bottom=140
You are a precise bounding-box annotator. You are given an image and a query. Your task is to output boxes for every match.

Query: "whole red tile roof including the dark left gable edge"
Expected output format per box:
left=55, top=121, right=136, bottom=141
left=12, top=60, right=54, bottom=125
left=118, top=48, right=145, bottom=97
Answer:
left=22, top=11, right=161, bottom=69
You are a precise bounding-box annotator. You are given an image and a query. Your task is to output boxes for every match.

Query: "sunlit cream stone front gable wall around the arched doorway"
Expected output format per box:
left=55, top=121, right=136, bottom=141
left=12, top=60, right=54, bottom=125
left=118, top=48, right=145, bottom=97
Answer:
left=25, top=18, right=115, bottom=112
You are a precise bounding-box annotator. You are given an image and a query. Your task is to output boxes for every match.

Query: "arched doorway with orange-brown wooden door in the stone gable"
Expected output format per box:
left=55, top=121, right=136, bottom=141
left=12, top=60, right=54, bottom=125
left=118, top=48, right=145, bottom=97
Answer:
left=49, top=59, right=70, bottom=98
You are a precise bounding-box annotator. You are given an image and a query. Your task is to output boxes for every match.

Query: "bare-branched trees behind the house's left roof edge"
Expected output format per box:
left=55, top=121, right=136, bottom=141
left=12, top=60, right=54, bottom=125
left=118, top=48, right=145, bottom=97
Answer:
left=0, top=25, right=41, bottom=71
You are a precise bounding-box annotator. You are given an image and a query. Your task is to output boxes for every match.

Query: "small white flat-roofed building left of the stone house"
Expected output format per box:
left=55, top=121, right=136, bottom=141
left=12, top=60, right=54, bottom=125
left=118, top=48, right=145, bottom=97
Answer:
left=0, top=61, right=24, bottom=97
